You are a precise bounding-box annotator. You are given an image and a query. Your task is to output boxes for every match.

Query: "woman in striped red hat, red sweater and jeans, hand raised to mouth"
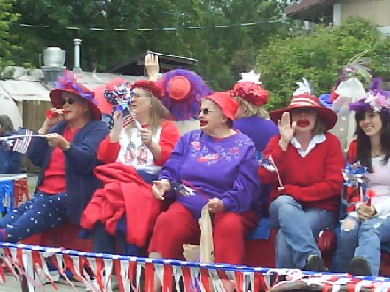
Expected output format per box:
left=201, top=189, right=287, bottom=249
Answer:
left=259, top=82, right=344, bottom=271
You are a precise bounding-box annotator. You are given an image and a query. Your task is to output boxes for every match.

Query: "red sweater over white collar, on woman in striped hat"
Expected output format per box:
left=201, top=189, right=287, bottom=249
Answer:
left=259, top=133, right=344, bottom=211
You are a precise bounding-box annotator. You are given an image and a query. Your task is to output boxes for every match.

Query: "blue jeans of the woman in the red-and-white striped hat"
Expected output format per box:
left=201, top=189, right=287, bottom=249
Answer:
left=270, top=195, right=335, bottom=269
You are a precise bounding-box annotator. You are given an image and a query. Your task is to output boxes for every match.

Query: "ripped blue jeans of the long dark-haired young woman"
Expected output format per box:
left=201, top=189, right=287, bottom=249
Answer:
left=334, top=216, right=390, bottom=276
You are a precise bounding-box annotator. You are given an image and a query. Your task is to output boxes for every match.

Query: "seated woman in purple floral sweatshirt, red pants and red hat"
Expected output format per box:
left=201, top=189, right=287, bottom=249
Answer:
left=149, top=92, right=261, bottom=264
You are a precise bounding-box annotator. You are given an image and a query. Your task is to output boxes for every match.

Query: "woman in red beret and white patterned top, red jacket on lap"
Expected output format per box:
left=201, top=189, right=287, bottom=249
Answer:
left=81, top=80, right=179, bottom=255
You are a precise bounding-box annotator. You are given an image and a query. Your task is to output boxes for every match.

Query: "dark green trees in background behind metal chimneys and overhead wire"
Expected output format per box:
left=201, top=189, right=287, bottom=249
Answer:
left=10, top=0, right=290, bottom=89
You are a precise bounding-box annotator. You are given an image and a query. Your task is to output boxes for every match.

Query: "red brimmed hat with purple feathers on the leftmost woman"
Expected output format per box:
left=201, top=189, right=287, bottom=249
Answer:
left=50, top=70, right=102, bottom=120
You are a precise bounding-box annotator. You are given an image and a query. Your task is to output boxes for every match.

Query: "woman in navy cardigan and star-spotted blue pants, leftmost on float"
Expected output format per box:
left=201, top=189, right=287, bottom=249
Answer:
left=0, top=71, right=108, bottom=242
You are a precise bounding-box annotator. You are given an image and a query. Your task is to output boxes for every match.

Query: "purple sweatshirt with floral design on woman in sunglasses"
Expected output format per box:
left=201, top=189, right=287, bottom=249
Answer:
left=160, top=130, right=261, bottom=218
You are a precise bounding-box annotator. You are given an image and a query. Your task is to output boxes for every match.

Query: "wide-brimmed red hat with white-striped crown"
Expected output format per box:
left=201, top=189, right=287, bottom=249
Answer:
left=269, top=93, right=337, bottom=130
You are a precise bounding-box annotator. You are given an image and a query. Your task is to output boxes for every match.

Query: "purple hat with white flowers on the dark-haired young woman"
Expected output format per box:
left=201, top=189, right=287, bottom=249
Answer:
left=349, top=78, right=390, bottom=112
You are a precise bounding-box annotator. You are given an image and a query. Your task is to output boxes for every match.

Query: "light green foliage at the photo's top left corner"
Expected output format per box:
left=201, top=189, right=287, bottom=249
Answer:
left=0, top=0, right=18, bottom=77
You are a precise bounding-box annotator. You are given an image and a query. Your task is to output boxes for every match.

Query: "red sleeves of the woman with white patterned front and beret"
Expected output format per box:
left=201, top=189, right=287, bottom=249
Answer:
left=97, top=121, right=180, bottom=166
